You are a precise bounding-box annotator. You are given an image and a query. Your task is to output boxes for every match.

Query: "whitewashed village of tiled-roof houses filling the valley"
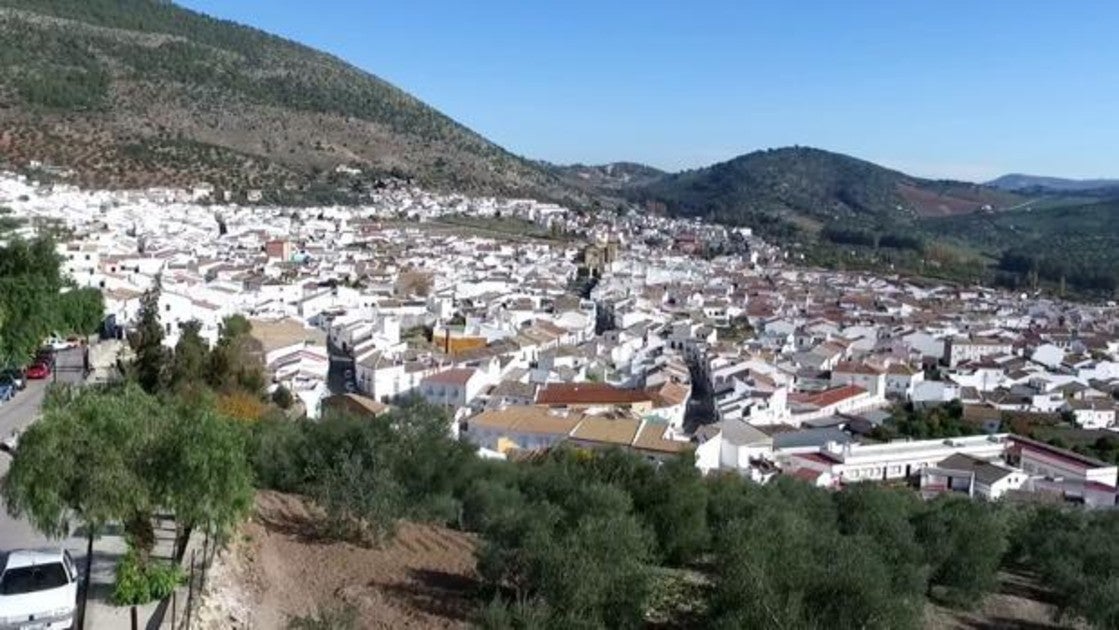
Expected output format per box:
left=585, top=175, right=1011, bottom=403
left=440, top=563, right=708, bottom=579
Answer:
left=0, top=168, right=1119, bottom=508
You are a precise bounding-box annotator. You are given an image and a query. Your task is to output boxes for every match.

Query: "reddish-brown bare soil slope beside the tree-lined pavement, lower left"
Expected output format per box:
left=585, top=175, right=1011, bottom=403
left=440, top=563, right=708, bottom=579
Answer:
left=198, top=491, right=478, bottom=629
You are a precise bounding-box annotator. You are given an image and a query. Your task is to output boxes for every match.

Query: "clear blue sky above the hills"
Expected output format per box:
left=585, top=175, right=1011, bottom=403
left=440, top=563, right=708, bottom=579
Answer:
left=181, top=0, right=1119, bottom=180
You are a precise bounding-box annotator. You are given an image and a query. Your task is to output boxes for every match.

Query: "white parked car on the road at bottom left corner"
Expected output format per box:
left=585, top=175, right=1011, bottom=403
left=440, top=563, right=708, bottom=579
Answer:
left=0, top=549, right=79, bottom=630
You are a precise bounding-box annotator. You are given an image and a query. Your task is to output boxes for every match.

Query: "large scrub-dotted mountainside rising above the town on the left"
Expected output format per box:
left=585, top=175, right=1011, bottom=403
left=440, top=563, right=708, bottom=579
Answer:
left=0, top=0, right=580, bottom=199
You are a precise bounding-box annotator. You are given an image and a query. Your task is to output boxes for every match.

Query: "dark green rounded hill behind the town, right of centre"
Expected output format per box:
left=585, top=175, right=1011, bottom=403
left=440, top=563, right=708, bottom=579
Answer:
left=628, top=147, right=1022, bottom=239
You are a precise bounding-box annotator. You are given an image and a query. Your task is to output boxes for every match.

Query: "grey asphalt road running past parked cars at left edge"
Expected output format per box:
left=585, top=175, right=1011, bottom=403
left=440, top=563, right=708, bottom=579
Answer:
left=0, top=349, right=85, bottom=590
